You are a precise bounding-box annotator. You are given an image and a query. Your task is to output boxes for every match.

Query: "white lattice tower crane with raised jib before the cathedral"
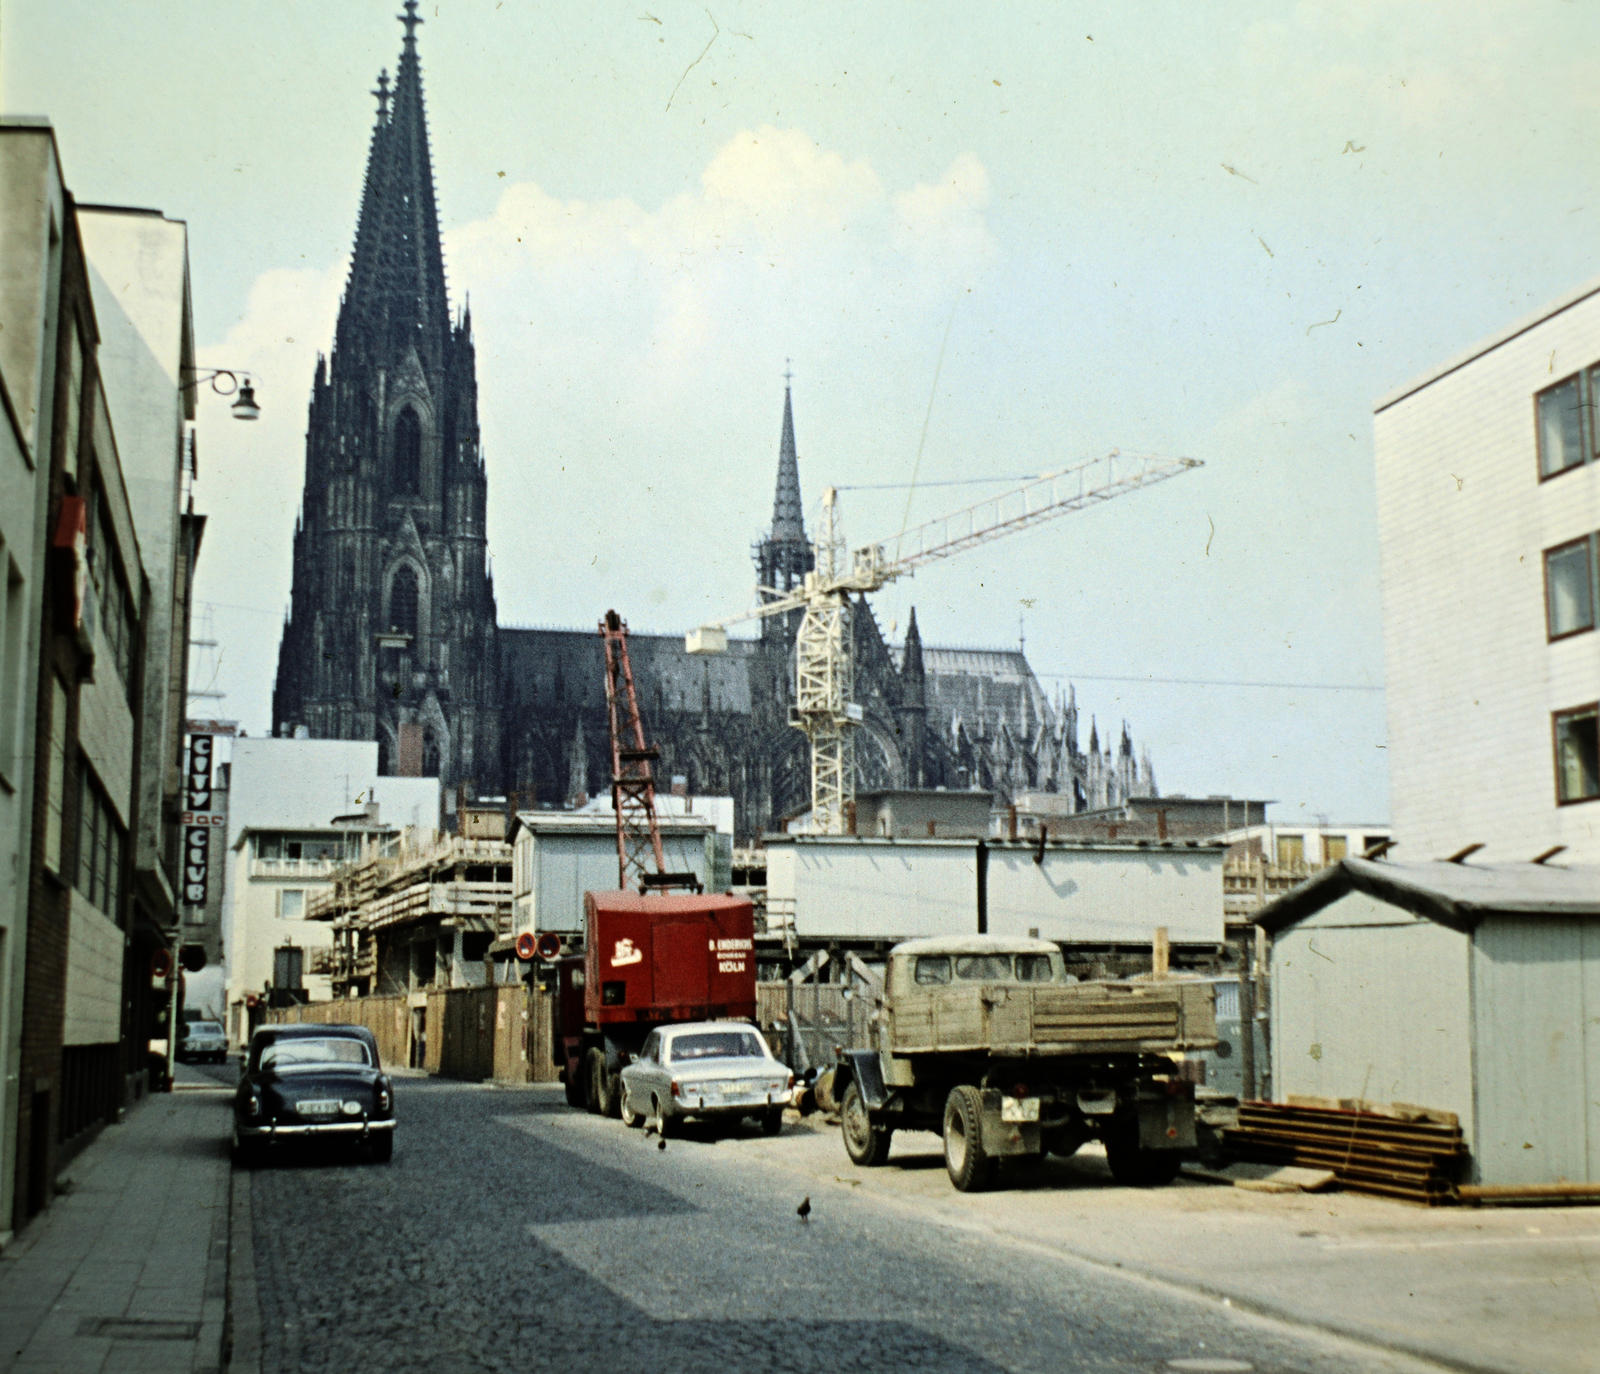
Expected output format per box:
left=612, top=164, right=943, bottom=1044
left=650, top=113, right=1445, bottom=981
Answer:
left=685, top=449, right=1203, bottom=835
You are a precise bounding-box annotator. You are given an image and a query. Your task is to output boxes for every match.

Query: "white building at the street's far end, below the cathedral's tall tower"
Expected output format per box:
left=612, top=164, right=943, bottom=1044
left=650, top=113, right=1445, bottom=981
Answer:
left=222, top=739, right=440, bottom=1044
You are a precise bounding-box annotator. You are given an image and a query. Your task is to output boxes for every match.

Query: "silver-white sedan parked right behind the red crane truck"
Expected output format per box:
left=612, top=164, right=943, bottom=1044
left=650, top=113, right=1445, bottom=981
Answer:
left=622, top=1021, right=795, bottom=1136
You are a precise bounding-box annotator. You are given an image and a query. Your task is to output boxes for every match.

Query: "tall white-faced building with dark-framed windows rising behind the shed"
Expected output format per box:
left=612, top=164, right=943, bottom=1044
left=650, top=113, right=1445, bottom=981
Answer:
left=1374, top=282, right=1600, bottom=862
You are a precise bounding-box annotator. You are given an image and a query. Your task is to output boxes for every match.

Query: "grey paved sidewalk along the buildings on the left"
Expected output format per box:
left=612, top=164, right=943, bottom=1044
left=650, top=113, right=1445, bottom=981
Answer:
left=0, top=1086, right=232, bottom=1374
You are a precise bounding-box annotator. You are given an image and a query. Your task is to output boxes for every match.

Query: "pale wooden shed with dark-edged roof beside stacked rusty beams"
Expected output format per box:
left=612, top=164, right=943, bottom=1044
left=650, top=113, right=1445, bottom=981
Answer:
left=1258, top=859, right=1600, bottom=1187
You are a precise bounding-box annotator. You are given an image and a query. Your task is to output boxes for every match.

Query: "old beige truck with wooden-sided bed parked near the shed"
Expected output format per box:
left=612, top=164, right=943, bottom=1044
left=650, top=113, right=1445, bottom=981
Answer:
left=832, top=936, right=1218, bottom=1192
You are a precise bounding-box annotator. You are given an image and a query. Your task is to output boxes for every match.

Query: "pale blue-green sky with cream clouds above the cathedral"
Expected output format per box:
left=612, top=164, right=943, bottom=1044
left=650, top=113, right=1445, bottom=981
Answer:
left=0, top=0, right=1600, bottom=824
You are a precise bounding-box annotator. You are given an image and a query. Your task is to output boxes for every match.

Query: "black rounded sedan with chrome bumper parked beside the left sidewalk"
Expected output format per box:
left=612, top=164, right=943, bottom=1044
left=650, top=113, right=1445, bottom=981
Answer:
left=234, top=1025, right=395, bottom=1166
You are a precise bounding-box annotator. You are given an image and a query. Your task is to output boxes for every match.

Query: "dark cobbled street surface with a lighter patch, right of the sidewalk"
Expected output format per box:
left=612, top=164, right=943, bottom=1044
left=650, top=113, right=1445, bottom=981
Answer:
left=240, top=1070, right=1452, bottom=1374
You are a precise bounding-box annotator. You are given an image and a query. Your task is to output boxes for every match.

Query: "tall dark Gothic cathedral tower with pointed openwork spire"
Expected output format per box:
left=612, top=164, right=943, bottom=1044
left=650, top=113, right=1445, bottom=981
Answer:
left=272, top=0, right=502, bottom=792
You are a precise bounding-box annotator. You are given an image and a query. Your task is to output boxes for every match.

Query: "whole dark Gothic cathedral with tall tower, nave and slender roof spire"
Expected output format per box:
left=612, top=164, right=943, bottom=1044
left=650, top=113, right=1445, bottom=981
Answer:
left=272, top=10, right=1155, bottom=843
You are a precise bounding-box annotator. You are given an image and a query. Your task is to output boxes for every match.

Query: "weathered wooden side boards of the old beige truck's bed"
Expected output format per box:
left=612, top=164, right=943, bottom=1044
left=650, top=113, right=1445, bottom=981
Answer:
left=891, top=979, right=1218, bottom=1059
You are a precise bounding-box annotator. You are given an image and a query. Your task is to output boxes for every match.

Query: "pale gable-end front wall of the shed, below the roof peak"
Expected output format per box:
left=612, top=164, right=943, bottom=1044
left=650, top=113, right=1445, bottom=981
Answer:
left=1272, top=893, right=1472, bottom=1145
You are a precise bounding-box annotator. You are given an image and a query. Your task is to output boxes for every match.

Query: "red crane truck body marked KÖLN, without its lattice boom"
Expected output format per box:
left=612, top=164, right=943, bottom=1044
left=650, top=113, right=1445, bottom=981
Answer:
left=552, top=891, right=755, bottom=1116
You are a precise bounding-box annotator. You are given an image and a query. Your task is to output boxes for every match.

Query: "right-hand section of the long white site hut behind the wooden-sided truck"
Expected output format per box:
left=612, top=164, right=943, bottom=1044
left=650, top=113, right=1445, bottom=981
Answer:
left=989, top=845, right=1222, bottom=945
